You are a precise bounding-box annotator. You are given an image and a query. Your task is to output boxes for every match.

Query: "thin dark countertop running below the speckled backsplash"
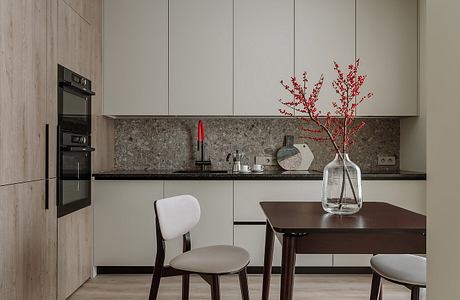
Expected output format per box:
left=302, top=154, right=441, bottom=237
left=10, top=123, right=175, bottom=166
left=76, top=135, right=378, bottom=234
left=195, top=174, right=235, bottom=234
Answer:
left=93, top=170, right=426, bottom=180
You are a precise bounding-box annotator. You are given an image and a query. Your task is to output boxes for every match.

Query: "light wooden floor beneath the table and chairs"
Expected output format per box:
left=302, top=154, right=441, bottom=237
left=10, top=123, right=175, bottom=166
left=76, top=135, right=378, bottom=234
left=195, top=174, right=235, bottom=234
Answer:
left=66, top=275, right=426, bottom=300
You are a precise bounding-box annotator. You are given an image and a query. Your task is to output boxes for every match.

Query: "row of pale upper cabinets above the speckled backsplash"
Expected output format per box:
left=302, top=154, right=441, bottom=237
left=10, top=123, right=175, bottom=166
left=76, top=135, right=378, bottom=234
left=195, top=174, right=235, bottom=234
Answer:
left=102, top=0, right=418, bottom=117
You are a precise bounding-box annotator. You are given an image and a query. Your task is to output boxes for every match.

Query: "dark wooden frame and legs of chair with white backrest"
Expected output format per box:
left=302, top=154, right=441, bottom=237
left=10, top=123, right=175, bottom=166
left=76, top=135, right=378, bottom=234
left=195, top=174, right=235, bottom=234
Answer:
left=149, top=201, right=249, bottom=300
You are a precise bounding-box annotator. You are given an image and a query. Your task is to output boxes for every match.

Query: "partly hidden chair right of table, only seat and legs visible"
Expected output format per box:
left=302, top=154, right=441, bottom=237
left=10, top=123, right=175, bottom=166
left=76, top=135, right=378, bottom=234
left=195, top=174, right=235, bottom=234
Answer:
left=370, top=254, right=426, bottom=300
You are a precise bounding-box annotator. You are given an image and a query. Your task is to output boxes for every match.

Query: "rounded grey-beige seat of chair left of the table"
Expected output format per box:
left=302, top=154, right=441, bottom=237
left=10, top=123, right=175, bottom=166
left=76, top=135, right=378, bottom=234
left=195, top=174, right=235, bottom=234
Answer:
left=169, top=245, right=249, bottom=274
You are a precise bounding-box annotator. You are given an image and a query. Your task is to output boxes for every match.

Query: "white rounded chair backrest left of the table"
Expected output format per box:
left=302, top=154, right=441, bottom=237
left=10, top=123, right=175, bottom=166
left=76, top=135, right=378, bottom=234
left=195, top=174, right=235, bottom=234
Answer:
left=155, top=195, right=201, bottom=241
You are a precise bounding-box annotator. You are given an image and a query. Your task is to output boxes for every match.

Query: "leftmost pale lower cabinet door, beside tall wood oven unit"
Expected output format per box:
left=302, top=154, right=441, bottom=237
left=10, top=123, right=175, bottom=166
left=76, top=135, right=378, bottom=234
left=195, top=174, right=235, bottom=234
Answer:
left=93, top=180, right=182, bottom=266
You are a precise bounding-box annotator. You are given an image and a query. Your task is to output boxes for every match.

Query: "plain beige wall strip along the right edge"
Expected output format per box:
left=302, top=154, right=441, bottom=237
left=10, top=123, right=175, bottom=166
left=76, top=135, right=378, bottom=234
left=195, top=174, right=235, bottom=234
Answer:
left=422, top=0, right=460, bottom=300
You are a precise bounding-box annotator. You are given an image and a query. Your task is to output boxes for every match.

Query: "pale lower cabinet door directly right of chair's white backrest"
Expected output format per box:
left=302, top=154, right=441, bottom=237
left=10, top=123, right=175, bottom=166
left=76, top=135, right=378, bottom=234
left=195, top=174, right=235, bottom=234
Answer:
left=164, top=180, right=233, bottom=248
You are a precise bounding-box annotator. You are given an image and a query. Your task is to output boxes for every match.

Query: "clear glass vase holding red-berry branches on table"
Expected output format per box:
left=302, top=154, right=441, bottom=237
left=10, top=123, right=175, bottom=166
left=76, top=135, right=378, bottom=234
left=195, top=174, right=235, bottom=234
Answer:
left=321, top=153, right=363, bottom=215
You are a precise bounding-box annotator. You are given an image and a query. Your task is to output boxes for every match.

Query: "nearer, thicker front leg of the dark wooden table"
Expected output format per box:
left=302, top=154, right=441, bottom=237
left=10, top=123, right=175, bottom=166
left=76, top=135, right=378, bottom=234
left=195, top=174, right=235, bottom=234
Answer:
left=280, top=235, right=296, bottom=300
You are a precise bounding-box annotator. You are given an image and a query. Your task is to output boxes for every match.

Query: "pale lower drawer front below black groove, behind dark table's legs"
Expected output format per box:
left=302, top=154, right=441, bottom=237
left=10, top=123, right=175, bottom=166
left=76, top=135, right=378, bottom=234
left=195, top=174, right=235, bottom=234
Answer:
left=235, top=225, right=332, bottom=267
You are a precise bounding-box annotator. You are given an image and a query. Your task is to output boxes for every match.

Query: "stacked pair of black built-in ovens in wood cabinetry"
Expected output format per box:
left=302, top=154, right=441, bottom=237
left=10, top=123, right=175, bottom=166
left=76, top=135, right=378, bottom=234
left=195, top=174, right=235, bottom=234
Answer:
left=57, top=65, right=95, bottom=217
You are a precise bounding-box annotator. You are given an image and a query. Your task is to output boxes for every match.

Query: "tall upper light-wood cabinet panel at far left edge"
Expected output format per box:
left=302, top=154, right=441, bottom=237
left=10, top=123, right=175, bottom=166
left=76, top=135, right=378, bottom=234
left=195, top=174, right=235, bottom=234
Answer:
left=0, top=0, right=46, bottom=185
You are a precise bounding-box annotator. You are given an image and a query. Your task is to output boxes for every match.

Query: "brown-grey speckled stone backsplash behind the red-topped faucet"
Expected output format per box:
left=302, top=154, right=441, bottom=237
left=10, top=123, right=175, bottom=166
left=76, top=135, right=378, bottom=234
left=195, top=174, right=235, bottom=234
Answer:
left=115, top=118, right=399, bottom=172
